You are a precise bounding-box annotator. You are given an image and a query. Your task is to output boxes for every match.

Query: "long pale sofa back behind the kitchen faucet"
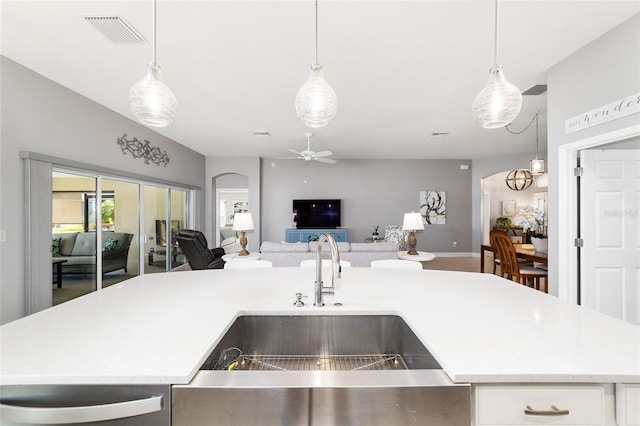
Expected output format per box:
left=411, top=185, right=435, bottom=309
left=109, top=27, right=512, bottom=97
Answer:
left=260, top=241, right=398, bottom=267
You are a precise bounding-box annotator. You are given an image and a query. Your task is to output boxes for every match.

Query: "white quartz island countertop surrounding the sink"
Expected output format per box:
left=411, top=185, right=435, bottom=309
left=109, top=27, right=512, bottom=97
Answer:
left=0, top=268, right=640, bottom=385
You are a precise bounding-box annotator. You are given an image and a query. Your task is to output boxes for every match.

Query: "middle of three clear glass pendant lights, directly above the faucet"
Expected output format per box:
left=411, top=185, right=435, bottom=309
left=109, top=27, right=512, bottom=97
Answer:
left=296, top=0, right=338, bottom=128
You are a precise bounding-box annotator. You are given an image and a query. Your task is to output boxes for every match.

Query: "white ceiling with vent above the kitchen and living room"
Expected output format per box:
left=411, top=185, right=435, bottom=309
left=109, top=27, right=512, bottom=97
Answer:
left=0, top=0, right=640, bottom=159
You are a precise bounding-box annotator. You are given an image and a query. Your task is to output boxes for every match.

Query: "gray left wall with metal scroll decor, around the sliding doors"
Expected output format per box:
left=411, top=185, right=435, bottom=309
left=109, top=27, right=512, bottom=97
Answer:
left=0, top=56, right=205, bottom=323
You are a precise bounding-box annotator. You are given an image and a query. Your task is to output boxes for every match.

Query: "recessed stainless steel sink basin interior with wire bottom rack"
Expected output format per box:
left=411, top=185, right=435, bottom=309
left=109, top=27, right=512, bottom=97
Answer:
left=202, top=315, right=441, bottom=371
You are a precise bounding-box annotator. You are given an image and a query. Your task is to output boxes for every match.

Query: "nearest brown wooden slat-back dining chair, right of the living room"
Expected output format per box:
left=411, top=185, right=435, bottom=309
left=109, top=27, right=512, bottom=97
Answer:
left=490, top=229, right=548, bottom=292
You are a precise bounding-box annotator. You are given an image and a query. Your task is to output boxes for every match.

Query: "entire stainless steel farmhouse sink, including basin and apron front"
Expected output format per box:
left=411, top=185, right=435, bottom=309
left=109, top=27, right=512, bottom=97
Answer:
left=172, top=315, right=471, bottom=426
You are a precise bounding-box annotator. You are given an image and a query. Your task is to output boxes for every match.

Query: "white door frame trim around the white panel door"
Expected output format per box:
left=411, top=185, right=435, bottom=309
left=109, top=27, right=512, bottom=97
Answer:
left=557, top=124, right=640, bottom=304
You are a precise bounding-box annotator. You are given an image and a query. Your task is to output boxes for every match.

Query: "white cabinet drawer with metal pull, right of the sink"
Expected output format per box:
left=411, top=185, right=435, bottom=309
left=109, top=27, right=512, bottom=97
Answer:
left=474, top=384, right=615, bottom=426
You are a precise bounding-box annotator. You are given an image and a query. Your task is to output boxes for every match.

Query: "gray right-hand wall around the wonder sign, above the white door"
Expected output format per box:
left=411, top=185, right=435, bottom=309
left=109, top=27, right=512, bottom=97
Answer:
left=547, top=14, right=640, bottom=294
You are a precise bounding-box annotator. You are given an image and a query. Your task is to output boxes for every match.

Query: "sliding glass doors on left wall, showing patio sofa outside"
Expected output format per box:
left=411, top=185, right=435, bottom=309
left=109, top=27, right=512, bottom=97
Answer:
left=51, top=169, right=190, bottom=305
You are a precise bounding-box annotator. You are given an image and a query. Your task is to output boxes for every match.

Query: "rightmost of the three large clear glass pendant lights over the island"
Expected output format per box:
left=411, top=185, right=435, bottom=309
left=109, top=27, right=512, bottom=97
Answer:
left=471, top=0, right=522, bottom=129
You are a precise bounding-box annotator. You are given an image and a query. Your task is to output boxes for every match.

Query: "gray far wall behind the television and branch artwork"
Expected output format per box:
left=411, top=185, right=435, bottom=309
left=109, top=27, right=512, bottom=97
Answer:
left=262, top=159, right=472, bottom=253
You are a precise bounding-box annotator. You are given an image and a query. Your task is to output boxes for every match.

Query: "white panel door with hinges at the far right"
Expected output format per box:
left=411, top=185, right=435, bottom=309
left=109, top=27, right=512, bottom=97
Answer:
left=580, top=149, right=640, bottom=324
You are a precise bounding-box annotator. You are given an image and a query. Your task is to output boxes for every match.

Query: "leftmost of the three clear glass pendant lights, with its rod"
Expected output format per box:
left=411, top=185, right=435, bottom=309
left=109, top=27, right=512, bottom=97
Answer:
left=129, top=0, right=178, bottom=127
